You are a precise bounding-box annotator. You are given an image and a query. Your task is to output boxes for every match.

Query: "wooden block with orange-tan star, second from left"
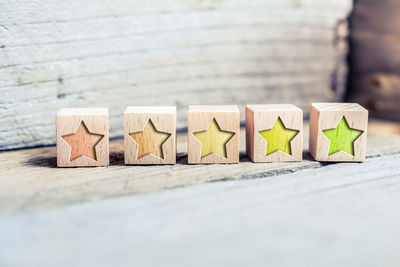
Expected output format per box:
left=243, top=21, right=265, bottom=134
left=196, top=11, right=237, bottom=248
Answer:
left=124, top=107, right=176, bottom=165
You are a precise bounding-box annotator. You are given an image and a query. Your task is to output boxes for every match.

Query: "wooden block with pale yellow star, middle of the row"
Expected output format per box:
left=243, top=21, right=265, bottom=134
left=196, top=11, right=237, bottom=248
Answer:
left=188, top=106, right=240, bottom=164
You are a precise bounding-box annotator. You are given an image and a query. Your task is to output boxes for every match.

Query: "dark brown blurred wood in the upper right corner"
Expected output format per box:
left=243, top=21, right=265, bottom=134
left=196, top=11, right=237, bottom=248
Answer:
left=349, top=0, right=400, bottom=121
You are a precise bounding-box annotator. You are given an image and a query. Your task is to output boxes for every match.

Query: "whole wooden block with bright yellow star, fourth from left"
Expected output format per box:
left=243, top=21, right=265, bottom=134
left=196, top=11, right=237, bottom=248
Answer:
left=246, top=104, right=303, bottom=162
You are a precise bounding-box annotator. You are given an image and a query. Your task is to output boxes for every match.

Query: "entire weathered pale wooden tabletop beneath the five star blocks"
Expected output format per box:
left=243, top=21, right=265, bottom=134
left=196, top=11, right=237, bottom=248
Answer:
left=0, top=124, right=400, bottom=267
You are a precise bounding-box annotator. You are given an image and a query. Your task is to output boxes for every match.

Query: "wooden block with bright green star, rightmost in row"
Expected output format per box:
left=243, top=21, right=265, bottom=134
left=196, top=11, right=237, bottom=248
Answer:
left=310, top=103, right=368, bottom=161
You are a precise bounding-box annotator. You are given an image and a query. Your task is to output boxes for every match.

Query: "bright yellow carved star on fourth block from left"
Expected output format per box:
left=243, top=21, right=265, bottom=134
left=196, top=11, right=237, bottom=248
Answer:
left=259, top=117, right=299, bottom=156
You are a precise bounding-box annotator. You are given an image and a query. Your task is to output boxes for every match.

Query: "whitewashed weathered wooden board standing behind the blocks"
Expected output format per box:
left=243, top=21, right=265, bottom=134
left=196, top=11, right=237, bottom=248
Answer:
left=0, top=0, right=352, bottom=150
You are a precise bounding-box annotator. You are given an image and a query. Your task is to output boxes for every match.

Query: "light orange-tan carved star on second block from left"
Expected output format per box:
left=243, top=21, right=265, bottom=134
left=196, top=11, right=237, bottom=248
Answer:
left=129, top=119, right=171, bottom=159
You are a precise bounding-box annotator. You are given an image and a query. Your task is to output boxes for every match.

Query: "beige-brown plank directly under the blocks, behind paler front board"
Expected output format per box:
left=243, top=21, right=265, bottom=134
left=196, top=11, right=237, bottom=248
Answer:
left=0, top=125, right=400, bottom=213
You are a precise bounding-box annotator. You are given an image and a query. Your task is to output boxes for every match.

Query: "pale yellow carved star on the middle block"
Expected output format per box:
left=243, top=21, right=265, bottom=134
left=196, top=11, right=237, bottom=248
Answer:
left=193, top=119, right=235, bottom=158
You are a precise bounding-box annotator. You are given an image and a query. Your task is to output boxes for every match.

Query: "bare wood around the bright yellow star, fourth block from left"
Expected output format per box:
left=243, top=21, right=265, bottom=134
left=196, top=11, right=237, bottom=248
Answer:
left=246, top=104, right=303, bottom=162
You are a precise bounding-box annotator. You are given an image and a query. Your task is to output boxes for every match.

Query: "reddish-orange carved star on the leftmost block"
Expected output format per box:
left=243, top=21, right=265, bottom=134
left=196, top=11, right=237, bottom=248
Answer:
left=62, top=121, right=104, bottom=161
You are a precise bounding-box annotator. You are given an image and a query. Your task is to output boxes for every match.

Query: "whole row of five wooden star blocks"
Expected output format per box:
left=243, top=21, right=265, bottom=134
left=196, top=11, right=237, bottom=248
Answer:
left=56, top=103, right=368, bottom=167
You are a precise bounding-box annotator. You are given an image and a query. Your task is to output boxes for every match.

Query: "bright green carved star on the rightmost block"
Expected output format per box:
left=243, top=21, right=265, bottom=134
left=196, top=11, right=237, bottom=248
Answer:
left=322, top=116, right=364, bottom=156
